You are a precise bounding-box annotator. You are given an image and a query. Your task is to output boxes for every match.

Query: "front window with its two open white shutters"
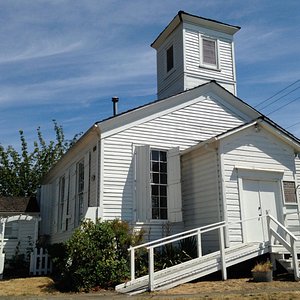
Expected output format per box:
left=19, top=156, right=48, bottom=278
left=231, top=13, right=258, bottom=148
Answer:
left=135, top=146, right=182, bottom=222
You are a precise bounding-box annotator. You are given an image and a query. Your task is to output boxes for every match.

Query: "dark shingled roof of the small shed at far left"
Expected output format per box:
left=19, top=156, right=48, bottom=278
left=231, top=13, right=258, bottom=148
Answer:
left=0, top=197, right=40, bottom=213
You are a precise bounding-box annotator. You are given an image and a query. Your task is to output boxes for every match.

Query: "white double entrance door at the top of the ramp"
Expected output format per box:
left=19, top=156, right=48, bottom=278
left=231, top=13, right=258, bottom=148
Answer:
left=242, top=179, right=281, bottom=242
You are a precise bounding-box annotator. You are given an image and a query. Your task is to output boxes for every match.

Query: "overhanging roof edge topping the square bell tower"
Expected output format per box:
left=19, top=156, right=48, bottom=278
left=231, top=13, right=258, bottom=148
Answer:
left=151, top=10, right=241, bottom=49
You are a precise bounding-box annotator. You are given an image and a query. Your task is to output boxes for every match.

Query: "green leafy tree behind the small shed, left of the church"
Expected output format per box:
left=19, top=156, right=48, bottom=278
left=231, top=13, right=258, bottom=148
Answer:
left=0, top=120, right=79, bottom=197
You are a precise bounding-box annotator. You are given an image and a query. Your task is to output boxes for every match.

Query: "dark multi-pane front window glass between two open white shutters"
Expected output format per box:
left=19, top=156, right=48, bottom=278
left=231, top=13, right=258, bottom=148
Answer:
left=150, top=150, right=168, bottom=219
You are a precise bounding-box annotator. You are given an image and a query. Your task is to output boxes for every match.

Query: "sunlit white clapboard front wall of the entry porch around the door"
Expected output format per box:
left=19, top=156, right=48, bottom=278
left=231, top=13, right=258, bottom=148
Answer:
left=220, top=128, right=295, bottom=242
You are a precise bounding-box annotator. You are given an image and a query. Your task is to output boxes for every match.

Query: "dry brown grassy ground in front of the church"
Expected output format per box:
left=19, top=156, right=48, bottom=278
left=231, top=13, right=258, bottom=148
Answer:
left=0, top=277, right=300, bottom=300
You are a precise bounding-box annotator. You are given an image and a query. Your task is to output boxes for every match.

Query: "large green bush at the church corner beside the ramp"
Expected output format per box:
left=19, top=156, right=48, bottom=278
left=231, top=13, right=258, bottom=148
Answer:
left=50, top=220, right=142, bottom=291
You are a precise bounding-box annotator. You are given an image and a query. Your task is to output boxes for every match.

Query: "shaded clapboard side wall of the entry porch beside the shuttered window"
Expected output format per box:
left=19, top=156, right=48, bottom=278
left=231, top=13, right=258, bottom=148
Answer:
left=182, top=149, right=220, bottom=253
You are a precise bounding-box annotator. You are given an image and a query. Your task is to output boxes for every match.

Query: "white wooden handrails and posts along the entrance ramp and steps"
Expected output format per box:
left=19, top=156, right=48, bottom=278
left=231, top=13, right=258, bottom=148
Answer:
left=128, top=212, right=299, bottom=291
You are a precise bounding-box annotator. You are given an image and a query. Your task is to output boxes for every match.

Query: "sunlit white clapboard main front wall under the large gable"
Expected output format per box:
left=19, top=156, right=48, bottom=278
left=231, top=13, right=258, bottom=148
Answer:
left=103, top=98, right=243, bottom=224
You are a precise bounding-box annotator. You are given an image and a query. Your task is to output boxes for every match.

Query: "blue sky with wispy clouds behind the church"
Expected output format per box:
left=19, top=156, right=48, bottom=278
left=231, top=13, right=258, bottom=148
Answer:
left=0, top=0, right=300, bottom=147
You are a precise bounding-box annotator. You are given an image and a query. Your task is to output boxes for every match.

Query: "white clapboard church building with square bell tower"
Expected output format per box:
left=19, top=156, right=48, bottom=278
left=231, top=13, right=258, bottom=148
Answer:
left=40, top=11, right=300, bottom=290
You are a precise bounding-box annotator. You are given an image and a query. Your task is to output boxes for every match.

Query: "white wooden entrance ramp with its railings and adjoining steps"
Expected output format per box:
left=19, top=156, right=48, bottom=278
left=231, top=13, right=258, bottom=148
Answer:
left=115, top=214, right=300, bottom=295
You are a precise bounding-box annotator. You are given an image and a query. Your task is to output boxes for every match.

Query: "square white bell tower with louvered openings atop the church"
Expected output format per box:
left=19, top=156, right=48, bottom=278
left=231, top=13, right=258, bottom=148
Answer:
left=151, top=11, right=240, bottom=99
